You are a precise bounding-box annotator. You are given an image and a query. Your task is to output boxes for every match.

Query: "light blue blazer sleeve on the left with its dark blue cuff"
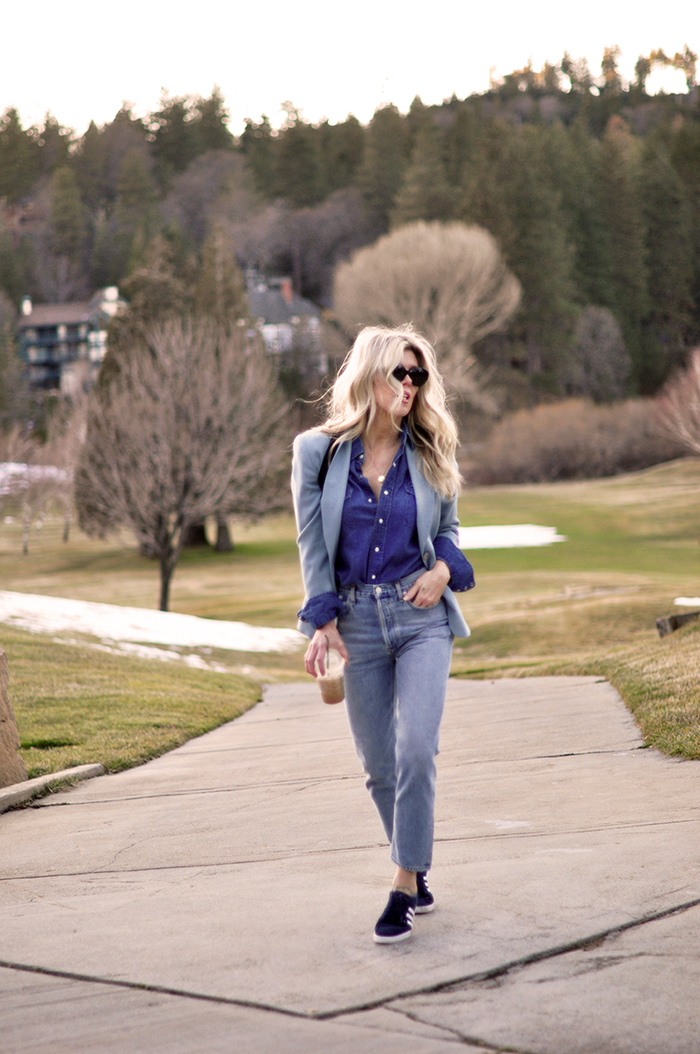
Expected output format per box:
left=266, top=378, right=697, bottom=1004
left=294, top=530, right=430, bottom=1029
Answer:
left=292, top=432, right=343, bottom=629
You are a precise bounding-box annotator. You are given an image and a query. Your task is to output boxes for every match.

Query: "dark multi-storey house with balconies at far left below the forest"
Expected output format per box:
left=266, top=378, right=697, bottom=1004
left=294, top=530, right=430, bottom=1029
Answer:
left=17, top=286, right=125, bottom=395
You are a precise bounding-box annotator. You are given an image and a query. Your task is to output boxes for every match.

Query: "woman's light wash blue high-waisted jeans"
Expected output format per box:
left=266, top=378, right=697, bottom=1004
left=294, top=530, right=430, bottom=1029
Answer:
left=338, top=572, right=452, bottom=871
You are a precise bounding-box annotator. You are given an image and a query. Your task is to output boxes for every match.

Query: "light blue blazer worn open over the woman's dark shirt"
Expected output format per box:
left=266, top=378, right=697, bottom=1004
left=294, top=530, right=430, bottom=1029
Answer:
left=292, top=431, right=469, bottom=637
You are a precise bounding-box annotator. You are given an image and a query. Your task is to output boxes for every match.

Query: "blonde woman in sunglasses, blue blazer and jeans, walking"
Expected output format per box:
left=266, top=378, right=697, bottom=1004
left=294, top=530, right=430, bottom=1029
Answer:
left=292, top=326, right=474, bottom=943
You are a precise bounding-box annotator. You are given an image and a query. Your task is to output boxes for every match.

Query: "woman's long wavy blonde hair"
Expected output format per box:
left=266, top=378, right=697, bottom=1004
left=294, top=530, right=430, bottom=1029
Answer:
left=319, top=325, right=462, bottom=497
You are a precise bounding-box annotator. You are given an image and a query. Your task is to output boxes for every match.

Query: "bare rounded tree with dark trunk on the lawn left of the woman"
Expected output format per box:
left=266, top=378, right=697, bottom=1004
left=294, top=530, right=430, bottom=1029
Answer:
left=76, top=318, right=289, bottom=611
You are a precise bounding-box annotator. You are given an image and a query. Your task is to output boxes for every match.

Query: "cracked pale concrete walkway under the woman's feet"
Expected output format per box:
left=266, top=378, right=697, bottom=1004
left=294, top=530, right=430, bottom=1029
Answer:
left=0, top=678, right=700, bottom=1054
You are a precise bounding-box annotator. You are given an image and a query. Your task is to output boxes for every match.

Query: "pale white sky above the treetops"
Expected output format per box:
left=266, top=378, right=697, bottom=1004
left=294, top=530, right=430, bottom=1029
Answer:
left=0, top=0, right=700, bottom=133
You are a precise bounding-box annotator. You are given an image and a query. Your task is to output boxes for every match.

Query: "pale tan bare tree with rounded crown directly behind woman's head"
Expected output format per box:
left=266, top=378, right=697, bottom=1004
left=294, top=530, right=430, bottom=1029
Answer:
left=334, top=220, right=520, bottom=401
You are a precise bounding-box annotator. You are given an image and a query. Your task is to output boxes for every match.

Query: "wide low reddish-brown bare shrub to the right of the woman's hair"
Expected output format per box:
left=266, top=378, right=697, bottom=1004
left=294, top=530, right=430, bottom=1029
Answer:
left=467, top=398, right=684, bottom=484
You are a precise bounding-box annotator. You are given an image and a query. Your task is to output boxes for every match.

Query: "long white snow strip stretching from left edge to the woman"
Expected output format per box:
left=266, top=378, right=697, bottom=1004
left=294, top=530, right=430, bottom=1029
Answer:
left=0, top=590, right=306, bottom=653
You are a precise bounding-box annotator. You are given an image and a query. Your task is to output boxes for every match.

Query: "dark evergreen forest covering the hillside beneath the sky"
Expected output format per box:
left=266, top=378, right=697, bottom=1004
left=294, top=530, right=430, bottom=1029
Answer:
left=0, top=47, right=700, bottom=403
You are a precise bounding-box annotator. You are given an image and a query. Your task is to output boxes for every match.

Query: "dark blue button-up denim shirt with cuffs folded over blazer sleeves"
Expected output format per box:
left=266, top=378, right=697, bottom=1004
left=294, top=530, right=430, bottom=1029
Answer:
left=299, top=430, right=473, bottom=628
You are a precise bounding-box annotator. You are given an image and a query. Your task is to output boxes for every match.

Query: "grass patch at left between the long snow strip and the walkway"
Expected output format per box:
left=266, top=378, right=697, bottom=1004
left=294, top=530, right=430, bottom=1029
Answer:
left=0, top=626, right=260, bottom=777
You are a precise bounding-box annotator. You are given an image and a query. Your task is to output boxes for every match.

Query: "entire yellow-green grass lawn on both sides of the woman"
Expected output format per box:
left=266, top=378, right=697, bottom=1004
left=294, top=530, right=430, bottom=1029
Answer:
left=0, top=458, right=700, bottom=775
